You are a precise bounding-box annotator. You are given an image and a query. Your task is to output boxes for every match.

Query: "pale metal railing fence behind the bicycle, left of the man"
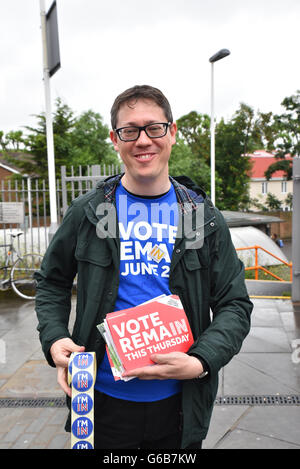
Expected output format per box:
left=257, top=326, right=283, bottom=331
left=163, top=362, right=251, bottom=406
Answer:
left=0, top=165, right=123, bottom=265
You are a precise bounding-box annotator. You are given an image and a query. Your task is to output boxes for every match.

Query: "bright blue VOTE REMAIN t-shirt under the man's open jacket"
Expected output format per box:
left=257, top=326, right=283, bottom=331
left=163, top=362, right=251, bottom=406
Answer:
left=95, top=183, right=181, bottom=402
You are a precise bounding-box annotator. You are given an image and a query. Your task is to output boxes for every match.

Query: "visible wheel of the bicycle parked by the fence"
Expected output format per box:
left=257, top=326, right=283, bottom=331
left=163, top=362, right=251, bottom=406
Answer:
left=10, top=253, right=43, bottom=300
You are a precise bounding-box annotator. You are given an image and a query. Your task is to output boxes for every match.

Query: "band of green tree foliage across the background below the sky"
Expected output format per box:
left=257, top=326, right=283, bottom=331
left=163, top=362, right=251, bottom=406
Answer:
left=0, top=91, right=300, bottom=210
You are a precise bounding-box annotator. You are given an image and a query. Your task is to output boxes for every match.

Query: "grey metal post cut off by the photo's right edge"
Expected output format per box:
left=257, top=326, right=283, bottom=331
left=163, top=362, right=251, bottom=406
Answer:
left=292, top=157, right=300, bottom=306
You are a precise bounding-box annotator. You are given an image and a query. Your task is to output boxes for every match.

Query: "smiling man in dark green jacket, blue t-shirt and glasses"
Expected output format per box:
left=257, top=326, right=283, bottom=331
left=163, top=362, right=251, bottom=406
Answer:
left=36, top=86, right=252, bottom=449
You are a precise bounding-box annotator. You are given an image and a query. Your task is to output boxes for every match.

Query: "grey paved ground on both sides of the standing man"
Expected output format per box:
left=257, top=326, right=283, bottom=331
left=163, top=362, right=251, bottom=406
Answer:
left=0, top=285, right=300, bottom=450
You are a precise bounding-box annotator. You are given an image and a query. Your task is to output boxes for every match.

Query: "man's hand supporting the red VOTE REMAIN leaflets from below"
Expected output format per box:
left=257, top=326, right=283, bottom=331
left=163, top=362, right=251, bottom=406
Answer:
left=123, top=352, right=203, bottom=379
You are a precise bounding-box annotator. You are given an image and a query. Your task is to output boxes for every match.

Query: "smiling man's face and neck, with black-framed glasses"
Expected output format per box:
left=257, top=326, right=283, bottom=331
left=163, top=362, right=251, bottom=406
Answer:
left=110, top=92, right=177, bottom=195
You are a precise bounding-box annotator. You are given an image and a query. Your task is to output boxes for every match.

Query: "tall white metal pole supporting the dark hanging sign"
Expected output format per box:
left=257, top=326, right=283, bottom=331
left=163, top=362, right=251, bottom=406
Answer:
left=40, top=0, right=57, bottom=237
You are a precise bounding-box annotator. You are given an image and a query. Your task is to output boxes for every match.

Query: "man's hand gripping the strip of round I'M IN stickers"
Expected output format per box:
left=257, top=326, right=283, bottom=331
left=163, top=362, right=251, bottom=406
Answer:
left=50, top=337, right=85, bottom=397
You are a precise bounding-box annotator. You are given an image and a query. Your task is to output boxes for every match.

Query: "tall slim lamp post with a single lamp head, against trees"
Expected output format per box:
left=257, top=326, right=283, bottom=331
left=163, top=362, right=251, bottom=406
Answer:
left=209, top=49, right=230, bottom=204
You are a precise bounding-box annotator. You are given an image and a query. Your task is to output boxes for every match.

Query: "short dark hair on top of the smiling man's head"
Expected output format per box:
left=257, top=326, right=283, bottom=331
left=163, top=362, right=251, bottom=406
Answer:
left=110, top=85, right=173, bottom=129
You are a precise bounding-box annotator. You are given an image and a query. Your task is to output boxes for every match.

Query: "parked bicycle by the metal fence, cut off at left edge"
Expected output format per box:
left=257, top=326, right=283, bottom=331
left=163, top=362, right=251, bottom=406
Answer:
left=0, top=231, right=43, bottom=300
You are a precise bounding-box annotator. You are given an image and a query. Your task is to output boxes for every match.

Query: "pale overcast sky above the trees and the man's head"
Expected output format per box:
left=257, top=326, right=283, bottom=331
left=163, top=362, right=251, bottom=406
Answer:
left=0, top=0, right=300, bottom=132
